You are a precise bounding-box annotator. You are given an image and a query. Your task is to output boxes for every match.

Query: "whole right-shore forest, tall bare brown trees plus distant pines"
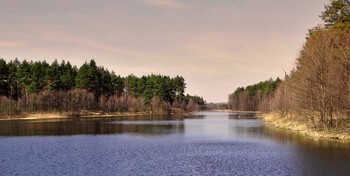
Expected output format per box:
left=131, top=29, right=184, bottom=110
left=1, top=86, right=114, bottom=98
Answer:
left=229, top=0, right=350, bottom=130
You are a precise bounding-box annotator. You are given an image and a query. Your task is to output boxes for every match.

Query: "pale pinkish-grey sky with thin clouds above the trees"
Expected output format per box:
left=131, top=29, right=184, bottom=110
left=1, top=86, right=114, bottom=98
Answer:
left=0, top=0, right=329, bottom=102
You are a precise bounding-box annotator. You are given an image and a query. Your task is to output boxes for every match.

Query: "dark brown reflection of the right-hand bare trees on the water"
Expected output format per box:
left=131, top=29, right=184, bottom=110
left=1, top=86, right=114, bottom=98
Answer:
left=264, top=127, right=350, bottom=175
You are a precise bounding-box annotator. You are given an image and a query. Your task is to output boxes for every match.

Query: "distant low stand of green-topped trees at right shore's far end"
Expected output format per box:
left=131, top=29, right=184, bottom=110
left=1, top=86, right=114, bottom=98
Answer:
left=228, top=78, right=281, bottom=111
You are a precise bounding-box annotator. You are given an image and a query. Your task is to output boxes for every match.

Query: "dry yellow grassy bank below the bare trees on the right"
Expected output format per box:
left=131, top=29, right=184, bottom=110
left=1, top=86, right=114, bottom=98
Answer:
left=263, top=113, right=350, bottom=142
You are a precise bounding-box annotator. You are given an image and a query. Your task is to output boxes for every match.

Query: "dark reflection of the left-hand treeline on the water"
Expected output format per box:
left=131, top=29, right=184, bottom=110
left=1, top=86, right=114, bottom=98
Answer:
left=0, top=116, right=184, bottom=136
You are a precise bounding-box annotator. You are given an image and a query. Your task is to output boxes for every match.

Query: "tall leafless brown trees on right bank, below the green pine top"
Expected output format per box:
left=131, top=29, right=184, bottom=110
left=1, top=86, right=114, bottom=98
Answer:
left=276, top=26, right=350, bottom=128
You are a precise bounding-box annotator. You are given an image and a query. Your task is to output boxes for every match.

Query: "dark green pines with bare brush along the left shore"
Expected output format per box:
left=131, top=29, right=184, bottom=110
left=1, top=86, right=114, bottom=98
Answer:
left=0, top=59, right=205, bottom=116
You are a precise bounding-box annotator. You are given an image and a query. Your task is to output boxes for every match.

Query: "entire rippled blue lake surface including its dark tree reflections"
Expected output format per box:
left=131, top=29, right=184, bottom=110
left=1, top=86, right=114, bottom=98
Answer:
left=0, top=112, right=350, bottom=175
